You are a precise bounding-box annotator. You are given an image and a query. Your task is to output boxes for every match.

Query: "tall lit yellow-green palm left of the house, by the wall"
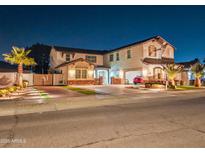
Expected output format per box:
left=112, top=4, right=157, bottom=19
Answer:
left=3, top=47, right=36, bottom=86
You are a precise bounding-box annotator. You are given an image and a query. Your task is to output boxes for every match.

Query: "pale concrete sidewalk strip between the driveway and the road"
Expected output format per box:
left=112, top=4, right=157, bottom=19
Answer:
left=0, top=89, right=205, bottom=117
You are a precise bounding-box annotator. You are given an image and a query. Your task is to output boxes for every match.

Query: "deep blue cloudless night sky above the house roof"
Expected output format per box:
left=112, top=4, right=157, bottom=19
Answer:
left=0, top=6, right=205, bottom=62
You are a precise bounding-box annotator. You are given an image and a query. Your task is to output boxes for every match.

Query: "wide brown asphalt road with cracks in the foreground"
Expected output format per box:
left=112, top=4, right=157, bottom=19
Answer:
left=0, top=92, right=205, bottom=147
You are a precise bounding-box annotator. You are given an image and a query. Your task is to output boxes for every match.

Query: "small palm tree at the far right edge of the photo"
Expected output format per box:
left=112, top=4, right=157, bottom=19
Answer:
left=191, top=62, right=205, bottom=87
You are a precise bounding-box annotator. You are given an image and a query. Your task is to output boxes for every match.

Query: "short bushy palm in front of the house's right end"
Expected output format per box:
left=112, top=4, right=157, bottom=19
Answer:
left=163, top=64, right=184, bottom=88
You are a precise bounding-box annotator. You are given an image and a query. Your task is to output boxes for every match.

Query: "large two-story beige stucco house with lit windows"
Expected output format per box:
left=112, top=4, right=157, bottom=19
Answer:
left=50, top=36, right=175, bottom=84
